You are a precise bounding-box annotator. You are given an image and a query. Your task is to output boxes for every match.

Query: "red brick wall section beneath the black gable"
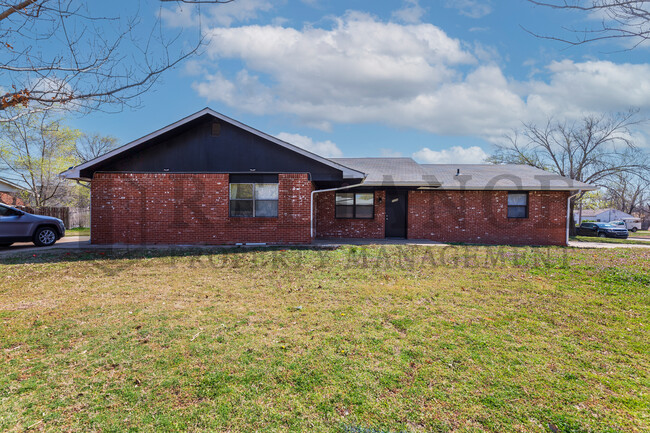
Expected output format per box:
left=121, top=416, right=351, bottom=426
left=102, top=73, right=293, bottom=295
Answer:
left=91, top=173, right=312, bottom=244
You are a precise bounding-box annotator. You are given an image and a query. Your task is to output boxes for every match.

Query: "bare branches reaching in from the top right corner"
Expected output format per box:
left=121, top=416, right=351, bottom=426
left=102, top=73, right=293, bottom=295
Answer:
left=527, top=0, right=650, bottom=47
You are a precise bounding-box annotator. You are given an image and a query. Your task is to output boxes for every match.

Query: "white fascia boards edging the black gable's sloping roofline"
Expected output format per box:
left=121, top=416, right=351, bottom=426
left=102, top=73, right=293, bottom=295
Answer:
left=59, top=108, right=365, bottom=180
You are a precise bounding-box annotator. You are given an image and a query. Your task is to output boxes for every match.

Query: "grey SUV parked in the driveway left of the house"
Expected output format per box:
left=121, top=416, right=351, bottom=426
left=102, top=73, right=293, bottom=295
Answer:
left=0, top=203, right=65, bottom=247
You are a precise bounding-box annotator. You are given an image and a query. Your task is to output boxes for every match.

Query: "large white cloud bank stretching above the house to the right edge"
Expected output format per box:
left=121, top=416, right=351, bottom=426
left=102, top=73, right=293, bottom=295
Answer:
left=194, top=13, right=650, bottom=141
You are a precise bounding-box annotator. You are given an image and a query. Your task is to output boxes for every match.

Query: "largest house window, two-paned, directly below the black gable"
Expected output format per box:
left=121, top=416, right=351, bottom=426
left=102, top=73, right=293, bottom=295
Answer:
left=230, top=183, right=278, bottom=217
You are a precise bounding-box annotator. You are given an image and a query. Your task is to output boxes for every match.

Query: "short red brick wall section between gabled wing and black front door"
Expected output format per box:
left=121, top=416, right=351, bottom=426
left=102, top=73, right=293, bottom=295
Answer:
left=315, top=189, right=386, bottom=239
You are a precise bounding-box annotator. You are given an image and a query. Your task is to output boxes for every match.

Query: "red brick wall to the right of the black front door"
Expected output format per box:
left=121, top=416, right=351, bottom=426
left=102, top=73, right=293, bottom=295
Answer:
left=408, top=191, right=568, bottom=245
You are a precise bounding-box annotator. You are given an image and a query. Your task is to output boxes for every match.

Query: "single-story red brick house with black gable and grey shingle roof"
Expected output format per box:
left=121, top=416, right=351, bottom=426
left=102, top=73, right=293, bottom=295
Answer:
left=62, top=108, right=596, bottom=245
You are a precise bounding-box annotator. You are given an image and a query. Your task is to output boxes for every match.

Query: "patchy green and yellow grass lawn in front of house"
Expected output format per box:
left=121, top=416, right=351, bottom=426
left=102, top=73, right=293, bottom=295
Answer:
left=0, top=246, right=650, bottom=433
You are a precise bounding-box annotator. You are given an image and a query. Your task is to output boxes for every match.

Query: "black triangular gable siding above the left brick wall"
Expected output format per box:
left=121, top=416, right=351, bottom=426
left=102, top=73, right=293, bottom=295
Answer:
left=82, top=116, right=341, bottom=181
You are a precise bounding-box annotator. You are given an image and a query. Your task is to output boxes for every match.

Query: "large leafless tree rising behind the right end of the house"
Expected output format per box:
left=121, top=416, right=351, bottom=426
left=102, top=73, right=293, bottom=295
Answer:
left=489, top=111, right=650, bottom=230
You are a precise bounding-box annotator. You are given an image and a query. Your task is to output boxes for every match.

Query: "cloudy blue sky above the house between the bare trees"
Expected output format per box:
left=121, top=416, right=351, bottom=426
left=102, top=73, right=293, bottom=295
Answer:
left=71, top=0, right=650, bottom=163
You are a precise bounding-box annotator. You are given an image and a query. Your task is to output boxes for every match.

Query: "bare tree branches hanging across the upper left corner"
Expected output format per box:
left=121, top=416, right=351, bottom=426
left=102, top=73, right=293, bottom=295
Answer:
left=0, top=0, right=232, bottom=122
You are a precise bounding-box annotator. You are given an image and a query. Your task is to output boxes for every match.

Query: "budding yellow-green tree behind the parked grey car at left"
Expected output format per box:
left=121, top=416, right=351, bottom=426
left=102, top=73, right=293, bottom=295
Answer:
left=0, top=112, right=79, bottom=207
